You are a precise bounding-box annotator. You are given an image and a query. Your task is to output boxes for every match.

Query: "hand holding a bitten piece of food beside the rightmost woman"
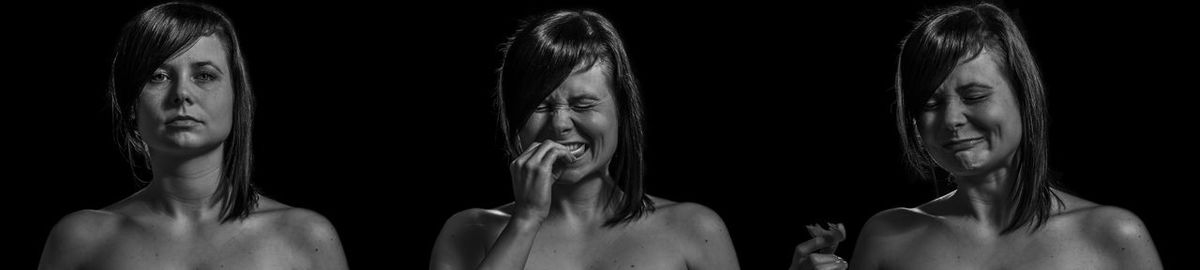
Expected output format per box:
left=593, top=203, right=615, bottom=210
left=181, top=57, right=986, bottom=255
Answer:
left=788, top=223, right=848, bottom=270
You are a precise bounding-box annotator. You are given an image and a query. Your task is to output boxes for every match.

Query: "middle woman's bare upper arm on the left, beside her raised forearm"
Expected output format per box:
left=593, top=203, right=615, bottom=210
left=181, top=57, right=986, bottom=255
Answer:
left=430, top=209, right=487, bottom=270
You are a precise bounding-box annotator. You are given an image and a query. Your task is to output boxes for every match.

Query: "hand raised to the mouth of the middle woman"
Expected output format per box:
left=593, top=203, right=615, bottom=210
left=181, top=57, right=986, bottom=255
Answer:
left=509, top=139, right=575, bottom=224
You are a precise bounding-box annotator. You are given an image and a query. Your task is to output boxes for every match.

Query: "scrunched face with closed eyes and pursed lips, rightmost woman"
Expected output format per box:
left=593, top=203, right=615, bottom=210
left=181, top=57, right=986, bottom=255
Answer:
left=917, top=49, right=1021, bottom=176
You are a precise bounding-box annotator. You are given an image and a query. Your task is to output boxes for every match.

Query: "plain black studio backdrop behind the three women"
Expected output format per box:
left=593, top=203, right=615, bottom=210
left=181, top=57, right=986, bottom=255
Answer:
left=4, top=1, right=1194, bottom=269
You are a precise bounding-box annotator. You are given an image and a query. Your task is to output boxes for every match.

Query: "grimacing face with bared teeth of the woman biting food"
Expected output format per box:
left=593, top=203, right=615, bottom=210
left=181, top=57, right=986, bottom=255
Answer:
left=520, top=62, right=618, bottom=184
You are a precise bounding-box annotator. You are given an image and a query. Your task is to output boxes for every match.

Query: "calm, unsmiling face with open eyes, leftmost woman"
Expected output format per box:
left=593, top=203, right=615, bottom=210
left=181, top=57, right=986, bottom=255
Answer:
left=137, top=35, right=234, bottom=154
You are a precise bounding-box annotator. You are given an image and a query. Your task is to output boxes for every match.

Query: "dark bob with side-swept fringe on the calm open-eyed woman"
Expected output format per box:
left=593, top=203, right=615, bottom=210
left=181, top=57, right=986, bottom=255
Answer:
left=108, top=2, right=258, bottom=222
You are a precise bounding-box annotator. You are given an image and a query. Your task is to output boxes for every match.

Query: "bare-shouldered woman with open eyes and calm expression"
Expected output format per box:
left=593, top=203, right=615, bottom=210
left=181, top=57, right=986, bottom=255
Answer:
left=40, top=2, right=347, bottom=269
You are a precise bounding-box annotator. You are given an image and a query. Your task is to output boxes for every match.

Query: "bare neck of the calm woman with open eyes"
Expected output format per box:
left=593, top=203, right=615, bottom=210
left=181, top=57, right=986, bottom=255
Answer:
left=146, top=146, right=224, bottom=221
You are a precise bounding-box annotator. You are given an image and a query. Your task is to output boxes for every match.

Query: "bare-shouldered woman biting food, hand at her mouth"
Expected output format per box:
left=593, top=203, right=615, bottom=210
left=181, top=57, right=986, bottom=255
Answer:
left=430, top=11, right=738, bottom=270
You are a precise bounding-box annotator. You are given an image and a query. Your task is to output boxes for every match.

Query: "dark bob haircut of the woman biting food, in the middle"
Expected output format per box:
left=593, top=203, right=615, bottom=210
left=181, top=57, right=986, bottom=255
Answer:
left=496, top=11, right=654, bottom=226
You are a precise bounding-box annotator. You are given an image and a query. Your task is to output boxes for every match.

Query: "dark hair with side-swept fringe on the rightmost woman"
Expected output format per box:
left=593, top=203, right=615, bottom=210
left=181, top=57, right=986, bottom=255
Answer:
left=895, top=4, right=1062, bottom=234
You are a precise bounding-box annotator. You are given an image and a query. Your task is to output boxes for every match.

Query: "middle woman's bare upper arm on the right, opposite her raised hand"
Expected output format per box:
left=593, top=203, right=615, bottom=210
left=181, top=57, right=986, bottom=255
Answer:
left=677, top=203, right=739, bottom=269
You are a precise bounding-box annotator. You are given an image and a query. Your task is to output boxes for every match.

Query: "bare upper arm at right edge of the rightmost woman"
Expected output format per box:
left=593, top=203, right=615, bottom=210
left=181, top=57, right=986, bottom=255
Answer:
left=1090, top=206, right=1163, bottom=269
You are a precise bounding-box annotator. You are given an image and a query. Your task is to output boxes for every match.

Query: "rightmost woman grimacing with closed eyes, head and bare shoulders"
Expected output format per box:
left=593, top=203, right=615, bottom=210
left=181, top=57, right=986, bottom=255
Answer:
left=850, top=4, right=1162, bottom=269
